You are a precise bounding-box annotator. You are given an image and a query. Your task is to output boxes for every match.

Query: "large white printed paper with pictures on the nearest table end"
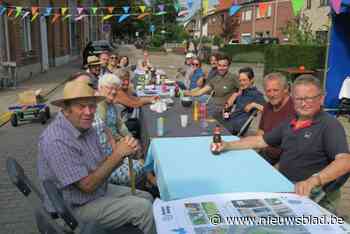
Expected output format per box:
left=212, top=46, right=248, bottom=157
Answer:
left=153, top=193, right=350, bottom=234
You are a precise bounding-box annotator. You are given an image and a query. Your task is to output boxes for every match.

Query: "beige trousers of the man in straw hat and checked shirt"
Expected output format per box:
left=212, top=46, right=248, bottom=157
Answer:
left=74, top=184, right=156, bottom=234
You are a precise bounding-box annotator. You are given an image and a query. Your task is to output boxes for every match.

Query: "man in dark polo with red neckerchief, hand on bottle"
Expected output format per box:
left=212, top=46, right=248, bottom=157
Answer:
left=212, top=75, right=350, bottom=211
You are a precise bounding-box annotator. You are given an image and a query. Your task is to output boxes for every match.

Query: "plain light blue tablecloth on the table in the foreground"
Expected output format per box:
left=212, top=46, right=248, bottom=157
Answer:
left=145, top=136, right=294, bottom=201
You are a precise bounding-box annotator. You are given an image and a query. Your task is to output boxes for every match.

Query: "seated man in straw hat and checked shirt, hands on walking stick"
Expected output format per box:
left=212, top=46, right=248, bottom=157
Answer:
left=38, top=80, right=156, bottom=233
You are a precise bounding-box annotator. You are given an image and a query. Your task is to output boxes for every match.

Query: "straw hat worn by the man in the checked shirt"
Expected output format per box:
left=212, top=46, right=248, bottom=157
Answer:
left=51, top=80, right=105, bottom=107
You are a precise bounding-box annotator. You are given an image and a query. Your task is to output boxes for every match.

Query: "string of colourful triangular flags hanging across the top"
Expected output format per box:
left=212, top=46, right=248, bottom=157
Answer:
left=0, top=0, right=330, bottom=23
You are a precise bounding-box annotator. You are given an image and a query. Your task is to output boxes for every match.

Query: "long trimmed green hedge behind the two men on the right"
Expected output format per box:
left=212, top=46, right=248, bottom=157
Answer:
left=220, top=45, right=326, bottom=74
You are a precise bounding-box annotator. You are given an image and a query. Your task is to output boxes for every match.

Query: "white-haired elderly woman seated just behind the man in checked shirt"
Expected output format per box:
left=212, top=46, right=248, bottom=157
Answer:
left=93, top=74, right=144, bottom=185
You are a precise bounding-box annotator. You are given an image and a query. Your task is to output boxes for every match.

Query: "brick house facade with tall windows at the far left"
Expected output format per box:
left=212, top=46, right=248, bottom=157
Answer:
left=0, top=0, right=100, bottom=84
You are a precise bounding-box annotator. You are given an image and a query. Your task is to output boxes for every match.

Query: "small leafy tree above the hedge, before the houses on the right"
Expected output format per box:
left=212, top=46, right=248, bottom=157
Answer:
left=280, top=14, right=322, bottom=45
